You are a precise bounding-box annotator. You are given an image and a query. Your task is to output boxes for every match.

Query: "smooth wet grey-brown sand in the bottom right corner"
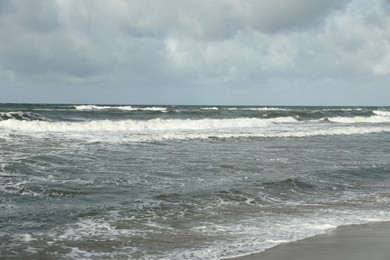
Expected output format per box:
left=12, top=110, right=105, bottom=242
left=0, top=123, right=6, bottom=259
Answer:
left=227, top=222, right=390, bottom=260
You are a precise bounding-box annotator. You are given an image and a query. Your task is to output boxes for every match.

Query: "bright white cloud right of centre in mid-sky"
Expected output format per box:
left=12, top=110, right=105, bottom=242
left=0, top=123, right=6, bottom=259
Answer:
left=166, top=31, right=297, bottom=81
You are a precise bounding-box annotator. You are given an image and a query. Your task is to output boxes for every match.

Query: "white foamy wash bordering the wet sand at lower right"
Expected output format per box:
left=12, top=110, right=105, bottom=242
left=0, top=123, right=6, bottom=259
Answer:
left=165, top=211, right=389, bottom=259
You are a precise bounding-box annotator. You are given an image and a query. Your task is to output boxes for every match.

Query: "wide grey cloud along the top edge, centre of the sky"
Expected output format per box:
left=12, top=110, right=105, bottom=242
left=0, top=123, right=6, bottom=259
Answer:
left=72, top=0, right=341, bottom=40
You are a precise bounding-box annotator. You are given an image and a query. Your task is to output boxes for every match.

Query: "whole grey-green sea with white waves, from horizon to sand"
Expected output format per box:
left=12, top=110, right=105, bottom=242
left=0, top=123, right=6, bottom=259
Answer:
left=0, top=104, right=390, bottom=259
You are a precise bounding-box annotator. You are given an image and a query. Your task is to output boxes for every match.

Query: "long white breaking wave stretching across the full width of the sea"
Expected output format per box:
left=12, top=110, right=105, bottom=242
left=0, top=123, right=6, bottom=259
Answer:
left=0, top=117, right=390, bottom=142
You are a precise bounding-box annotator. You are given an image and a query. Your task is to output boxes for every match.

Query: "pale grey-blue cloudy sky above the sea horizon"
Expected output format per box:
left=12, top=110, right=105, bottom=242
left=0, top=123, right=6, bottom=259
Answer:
left=0, top=0, right=390, bottom=106
